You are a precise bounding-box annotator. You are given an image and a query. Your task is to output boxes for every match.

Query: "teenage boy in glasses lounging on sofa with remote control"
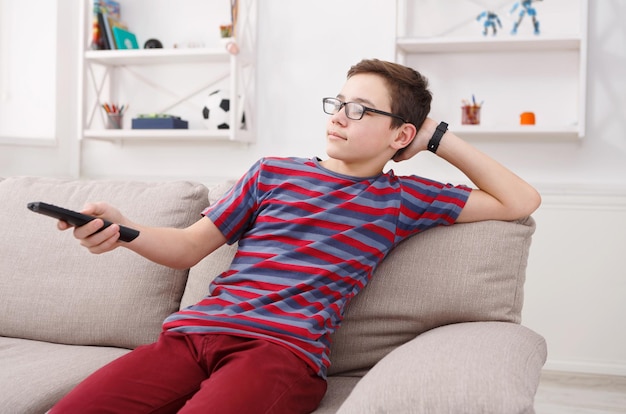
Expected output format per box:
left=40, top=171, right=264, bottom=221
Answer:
left=52, top=60, right=540, bottom=414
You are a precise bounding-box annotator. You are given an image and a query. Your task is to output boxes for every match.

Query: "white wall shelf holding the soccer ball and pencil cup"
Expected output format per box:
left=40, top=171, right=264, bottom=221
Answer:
left=79, top=0, right=257, bottom=152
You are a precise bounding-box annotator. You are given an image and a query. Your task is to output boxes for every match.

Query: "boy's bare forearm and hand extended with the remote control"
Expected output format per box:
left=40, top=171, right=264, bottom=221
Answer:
left=58, top=203, right=226, bottom=269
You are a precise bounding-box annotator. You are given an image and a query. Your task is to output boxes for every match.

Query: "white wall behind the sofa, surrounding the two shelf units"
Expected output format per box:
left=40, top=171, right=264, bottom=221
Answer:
left=0, top=0, right=626, bottom=375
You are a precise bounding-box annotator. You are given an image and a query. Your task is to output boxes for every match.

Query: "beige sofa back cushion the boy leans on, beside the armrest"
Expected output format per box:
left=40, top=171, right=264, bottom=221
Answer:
left=181, top=183, right=535, bottom=375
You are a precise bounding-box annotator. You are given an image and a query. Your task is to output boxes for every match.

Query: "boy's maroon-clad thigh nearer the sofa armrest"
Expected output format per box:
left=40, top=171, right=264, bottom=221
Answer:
left=180, top=335, right=326, bottom=414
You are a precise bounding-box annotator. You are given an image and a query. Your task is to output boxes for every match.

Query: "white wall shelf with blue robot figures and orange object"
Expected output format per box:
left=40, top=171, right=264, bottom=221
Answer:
left=396, top=0, right=587, bottom=141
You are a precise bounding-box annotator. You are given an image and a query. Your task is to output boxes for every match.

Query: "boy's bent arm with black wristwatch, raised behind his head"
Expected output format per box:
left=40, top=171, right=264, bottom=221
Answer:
left=396, top=118, right=541, bottom=222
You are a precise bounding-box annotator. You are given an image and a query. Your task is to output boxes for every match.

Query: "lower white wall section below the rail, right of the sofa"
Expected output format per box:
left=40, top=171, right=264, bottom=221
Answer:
left=522, top=192, right=626, bottom=375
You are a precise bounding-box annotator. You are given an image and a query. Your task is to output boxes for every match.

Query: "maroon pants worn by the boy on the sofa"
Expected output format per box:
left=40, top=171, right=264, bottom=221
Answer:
left=51, top=332, right=326, bottom=414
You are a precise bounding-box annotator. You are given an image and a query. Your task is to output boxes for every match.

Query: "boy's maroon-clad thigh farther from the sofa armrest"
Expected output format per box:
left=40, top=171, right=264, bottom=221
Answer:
left=51, top=333, right=207, bottom=414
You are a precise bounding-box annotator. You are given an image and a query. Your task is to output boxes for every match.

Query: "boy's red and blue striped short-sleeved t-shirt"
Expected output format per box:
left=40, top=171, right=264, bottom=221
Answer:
left=163, top=158, right=471, bottom=377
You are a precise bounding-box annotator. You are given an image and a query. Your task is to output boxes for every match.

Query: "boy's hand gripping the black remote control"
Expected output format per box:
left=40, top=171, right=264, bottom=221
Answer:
left=57, top=203, right=125, bottom=254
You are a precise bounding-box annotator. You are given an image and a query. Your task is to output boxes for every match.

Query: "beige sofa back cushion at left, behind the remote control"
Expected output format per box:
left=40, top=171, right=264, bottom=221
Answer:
left=0, top=177, right=208, bottom=348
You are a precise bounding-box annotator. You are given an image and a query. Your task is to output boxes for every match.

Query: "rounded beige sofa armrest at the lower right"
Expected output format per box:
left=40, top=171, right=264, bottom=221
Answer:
left=338, top=322, right=547, bottom=414
